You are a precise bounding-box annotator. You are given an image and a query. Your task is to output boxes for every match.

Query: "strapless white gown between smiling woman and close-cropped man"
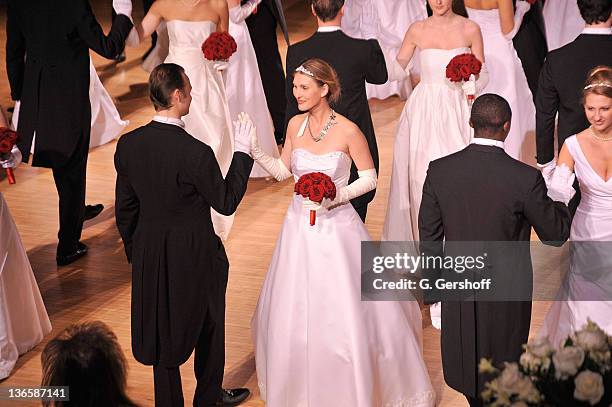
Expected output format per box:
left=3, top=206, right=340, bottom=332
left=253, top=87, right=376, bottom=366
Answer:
left=382, top=47, right=472, bottom=241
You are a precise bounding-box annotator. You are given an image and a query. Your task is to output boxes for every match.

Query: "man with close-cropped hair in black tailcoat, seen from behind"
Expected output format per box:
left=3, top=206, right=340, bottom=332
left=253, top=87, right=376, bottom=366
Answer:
left=418, top=94, right=573, bottom=406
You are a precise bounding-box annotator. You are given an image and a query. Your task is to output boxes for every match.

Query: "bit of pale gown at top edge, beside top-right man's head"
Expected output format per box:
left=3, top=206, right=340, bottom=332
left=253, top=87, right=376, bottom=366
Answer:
left=542, top=0, right=585, bottom=52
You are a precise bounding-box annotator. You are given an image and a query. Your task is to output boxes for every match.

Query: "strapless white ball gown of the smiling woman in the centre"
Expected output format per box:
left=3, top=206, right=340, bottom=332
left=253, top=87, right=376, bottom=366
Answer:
left=251, top=123, right=435, bottom=407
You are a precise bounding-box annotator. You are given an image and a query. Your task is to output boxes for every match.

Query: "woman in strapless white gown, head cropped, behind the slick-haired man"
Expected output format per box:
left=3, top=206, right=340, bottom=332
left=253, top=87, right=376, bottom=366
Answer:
left=131, top=0, right=234, bottom=240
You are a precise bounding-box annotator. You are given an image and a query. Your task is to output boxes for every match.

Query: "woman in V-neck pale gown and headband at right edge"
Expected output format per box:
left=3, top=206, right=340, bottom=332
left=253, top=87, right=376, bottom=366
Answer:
left=540, top=67, right=612, bottom=345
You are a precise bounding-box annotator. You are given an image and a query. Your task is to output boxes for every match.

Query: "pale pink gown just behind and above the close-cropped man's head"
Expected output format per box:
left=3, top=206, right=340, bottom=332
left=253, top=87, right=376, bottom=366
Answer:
left=467, top=8, right=535, bottom=164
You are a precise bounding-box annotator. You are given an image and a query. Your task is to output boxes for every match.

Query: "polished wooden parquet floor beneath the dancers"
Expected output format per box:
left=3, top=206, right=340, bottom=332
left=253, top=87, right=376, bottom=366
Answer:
left=0, top=0, right=548, bottom=407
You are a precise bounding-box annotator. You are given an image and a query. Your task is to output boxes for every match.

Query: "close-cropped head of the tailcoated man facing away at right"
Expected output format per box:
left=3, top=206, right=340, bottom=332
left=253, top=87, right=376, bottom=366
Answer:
left=470, top=93, right=512, bottom=134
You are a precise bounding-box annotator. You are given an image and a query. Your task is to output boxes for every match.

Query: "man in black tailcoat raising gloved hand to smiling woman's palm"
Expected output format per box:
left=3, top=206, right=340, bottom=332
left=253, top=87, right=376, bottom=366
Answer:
left=115, top=64, right=254, bottom=407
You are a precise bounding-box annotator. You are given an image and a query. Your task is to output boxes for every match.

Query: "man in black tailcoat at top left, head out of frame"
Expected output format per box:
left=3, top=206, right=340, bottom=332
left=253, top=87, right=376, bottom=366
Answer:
left=6, top=0, right=132, bottom=265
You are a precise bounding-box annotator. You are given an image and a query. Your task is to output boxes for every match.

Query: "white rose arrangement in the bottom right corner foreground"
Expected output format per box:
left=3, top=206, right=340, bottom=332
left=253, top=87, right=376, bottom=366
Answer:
left=479, top=320, right=612, bottom=407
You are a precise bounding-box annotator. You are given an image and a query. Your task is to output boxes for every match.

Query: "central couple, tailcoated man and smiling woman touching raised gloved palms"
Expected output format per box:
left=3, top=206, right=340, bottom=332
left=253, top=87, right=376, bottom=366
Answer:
left=115, top=59, right=435, bottom=407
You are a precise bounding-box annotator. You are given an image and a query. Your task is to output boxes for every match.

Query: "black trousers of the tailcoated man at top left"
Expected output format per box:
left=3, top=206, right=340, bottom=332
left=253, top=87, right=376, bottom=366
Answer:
left=53, top=129, right=89, bottom=255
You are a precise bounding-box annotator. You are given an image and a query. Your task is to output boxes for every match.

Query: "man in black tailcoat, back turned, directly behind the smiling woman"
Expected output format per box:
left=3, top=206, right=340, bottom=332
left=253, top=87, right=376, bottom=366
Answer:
left=285, top=0, right=387, bottom=222
